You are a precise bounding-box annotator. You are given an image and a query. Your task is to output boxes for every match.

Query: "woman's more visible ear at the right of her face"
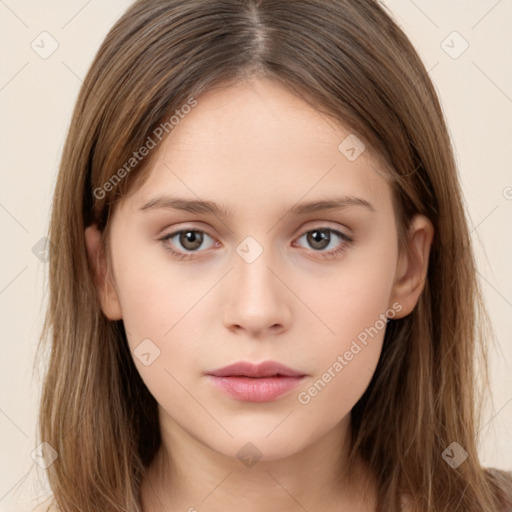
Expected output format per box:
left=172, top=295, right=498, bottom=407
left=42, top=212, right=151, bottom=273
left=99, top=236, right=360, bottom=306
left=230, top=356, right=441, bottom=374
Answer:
left=391, top=215, right=434, bottom=318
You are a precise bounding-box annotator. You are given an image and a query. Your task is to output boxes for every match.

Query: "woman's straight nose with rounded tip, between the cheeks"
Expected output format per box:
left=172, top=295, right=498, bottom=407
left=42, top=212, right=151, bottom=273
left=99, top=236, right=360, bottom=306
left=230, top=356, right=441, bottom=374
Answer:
left=223, top=239, right=293, bottom=337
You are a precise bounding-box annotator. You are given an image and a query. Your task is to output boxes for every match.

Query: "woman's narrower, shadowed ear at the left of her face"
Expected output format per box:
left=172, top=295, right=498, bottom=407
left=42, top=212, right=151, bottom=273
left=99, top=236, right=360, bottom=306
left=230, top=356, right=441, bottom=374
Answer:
left=85, top=224, right=122, bottom=320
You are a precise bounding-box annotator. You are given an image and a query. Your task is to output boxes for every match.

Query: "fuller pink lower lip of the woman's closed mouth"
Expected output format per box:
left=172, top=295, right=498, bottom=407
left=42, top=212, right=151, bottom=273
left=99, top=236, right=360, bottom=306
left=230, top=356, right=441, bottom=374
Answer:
left=209, top=375, right=304, bottom=402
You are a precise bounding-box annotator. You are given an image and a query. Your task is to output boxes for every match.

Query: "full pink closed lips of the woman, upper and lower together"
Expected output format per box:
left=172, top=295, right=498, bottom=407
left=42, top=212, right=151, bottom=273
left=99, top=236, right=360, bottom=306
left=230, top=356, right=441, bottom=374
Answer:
left=207, top=361, right=306, bottom=402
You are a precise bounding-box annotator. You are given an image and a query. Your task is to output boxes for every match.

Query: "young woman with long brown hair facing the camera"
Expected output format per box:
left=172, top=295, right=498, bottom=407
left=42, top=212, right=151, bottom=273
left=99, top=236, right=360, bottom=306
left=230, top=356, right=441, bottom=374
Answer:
left=34, top=0, right=512, bottom=512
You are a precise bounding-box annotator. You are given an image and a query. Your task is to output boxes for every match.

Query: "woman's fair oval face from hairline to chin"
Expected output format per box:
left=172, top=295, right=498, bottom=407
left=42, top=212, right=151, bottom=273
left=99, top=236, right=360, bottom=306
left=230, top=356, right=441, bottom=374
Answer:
left=87, top=79, right=428, bottom=460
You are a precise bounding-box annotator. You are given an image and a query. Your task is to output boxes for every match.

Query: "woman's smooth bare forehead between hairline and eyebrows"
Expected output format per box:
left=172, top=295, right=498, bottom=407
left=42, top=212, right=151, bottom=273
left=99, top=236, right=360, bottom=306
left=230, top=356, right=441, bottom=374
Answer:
left=122, top=79, right=391, bottom=219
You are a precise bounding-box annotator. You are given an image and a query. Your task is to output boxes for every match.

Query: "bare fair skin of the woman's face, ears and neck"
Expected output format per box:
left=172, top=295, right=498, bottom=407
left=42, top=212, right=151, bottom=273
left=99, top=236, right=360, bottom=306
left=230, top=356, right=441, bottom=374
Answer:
left=85, top=78, right=433, bottom=512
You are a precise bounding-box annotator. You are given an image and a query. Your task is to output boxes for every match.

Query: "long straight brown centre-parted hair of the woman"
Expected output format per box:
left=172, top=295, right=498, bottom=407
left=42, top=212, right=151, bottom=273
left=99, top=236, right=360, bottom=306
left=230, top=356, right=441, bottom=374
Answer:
left=33, top=0, right=512, bottom=512
